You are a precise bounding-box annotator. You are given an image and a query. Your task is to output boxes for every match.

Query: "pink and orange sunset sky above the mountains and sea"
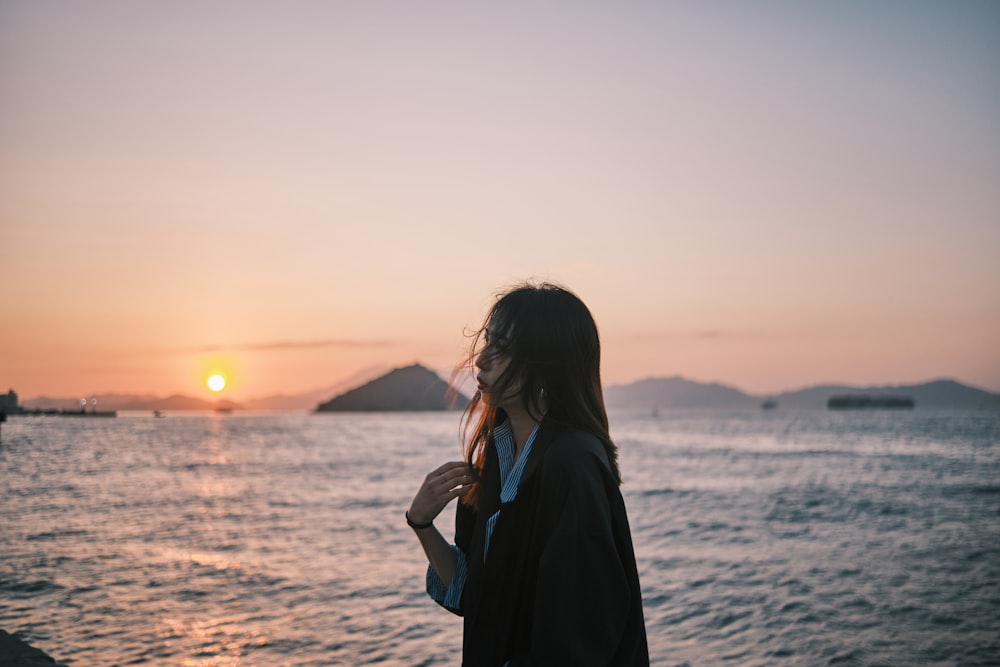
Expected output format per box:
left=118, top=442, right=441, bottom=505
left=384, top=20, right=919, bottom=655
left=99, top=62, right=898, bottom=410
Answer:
left=0, top=0, right=1000, bottom=400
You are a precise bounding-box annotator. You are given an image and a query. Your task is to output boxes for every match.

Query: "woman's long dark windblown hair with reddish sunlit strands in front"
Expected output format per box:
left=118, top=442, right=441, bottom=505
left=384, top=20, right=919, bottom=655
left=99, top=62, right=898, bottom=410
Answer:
left=462, top=283, right=621, bottom=508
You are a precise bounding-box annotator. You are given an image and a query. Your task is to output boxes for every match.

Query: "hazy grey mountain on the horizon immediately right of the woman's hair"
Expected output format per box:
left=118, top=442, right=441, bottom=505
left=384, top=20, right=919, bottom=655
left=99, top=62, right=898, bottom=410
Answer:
left=604, top=376, right=761, bottom=410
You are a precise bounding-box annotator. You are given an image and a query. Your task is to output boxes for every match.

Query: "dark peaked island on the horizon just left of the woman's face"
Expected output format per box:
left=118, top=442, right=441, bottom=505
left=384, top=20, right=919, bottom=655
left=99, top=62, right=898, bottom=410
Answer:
left=316, top=364, right=469, bottom=412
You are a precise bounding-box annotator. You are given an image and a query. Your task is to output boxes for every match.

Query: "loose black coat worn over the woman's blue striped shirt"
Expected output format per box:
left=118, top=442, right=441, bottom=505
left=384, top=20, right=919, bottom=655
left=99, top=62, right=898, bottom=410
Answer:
left=453, top=418, right=649, bottom=667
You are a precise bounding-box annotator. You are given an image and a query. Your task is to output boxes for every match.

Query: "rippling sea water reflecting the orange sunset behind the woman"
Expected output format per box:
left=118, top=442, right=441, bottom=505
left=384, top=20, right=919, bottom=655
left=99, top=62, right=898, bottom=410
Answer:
left=0, top=409, right=1000, bottom=667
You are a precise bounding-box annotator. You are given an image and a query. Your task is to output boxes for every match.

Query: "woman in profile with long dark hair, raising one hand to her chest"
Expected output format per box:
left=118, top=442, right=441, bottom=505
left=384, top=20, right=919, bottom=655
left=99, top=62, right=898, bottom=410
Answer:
left=406, top=285, right=649, bottom=667
